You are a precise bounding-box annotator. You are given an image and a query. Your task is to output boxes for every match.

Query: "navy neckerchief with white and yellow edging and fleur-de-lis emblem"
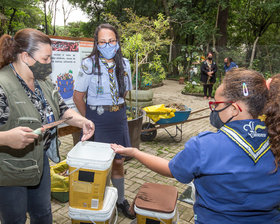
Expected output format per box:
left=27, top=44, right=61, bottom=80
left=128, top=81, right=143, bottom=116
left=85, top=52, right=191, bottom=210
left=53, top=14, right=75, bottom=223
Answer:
left=220, top=119, right=270, bottom=163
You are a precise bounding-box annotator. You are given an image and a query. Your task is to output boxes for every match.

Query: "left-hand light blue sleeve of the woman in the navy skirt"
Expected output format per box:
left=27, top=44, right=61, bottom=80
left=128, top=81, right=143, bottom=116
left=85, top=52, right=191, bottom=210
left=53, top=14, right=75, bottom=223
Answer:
left=74, top=58, right=93, bottom=92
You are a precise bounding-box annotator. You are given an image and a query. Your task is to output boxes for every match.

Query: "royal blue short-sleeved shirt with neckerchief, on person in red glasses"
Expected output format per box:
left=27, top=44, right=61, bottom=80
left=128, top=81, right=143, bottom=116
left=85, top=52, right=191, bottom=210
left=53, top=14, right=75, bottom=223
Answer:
left=169, top=120, right=280, bottom=224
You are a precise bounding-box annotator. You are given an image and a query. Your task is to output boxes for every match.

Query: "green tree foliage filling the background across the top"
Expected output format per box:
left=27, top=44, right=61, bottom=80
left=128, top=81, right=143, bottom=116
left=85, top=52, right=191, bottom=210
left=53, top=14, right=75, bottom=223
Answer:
left=0, top=0, right=280, bottom=79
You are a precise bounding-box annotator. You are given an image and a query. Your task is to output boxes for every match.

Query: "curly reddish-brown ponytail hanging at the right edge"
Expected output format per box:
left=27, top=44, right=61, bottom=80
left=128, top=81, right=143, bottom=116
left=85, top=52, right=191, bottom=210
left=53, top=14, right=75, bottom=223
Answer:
left=264, top=74, right=280, bottom=170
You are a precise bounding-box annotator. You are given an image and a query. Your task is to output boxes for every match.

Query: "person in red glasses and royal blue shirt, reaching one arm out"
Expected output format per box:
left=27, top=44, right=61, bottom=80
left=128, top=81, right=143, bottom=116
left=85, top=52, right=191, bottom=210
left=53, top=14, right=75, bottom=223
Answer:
left=112, top=69, right=280, bottom=224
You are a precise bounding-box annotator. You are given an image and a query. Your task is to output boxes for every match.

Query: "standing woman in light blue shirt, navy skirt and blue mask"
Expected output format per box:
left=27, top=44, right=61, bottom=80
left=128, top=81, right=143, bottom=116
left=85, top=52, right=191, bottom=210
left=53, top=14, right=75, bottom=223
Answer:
left=74, top=24, right=134, bottom=219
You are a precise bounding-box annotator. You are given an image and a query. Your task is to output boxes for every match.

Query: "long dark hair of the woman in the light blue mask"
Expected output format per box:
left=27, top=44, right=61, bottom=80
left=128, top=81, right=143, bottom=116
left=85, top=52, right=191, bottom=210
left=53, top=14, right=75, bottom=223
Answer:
left=88, top=24, right=125, bottom=97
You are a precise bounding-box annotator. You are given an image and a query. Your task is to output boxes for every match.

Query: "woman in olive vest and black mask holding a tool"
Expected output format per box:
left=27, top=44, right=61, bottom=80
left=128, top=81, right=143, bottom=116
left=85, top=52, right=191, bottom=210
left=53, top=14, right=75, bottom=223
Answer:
left=0, top=29, right=94, bottom=224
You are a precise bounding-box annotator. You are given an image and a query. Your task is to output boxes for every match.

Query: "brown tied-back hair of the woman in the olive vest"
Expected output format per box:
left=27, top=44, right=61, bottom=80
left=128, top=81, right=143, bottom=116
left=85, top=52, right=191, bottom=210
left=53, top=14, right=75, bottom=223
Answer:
left=0, top=28, right=51, bottom=68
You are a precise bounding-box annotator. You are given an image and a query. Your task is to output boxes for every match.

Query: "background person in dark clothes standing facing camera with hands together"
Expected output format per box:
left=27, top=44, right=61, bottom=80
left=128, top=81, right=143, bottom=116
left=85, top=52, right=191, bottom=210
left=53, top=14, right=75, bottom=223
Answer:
left=200, top=52, right=218, bottom=100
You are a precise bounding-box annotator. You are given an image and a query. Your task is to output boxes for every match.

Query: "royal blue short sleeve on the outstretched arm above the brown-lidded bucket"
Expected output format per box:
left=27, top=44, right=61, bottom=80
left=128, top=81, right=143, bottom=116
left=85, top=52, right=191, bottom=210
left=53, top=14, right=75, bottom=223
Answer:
left=168, top=136, right=201, bottom=183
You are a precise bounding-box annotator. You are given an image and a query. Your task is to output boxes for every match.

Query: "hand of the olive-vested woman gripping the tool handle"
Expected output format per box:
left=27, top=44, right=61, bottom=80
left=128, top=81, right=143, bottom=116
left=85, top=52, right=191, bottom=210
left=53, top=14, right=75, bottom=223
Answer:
left=0, top=127, right=39, bottom=149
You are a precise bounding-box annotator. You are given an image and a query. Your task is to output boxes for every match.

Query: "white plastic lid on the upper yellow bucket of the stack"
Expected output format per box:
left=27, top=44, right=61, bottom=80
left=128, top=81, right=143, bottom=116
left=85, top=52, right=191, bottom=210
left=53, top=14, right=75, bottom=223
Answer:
left=66, top=141, right=115, bottom=170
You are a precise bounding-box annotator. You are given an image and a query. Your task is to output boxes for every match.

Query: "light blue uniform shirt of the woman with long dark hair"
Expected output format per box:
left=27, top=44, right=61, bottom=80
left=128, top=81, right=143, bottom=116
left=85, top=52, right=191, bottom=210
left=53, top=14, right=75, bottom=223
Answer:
left=75, top=58, right=132, bottom=106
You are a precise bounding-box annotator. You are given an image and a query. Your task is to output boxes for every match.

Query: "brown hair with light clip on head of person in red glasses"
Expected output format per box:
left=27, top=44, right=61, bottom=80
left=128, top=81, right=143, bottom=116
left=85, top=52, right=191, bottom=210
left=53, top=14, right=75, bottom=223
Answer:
left=223, top=68, right=268, bottom=119
